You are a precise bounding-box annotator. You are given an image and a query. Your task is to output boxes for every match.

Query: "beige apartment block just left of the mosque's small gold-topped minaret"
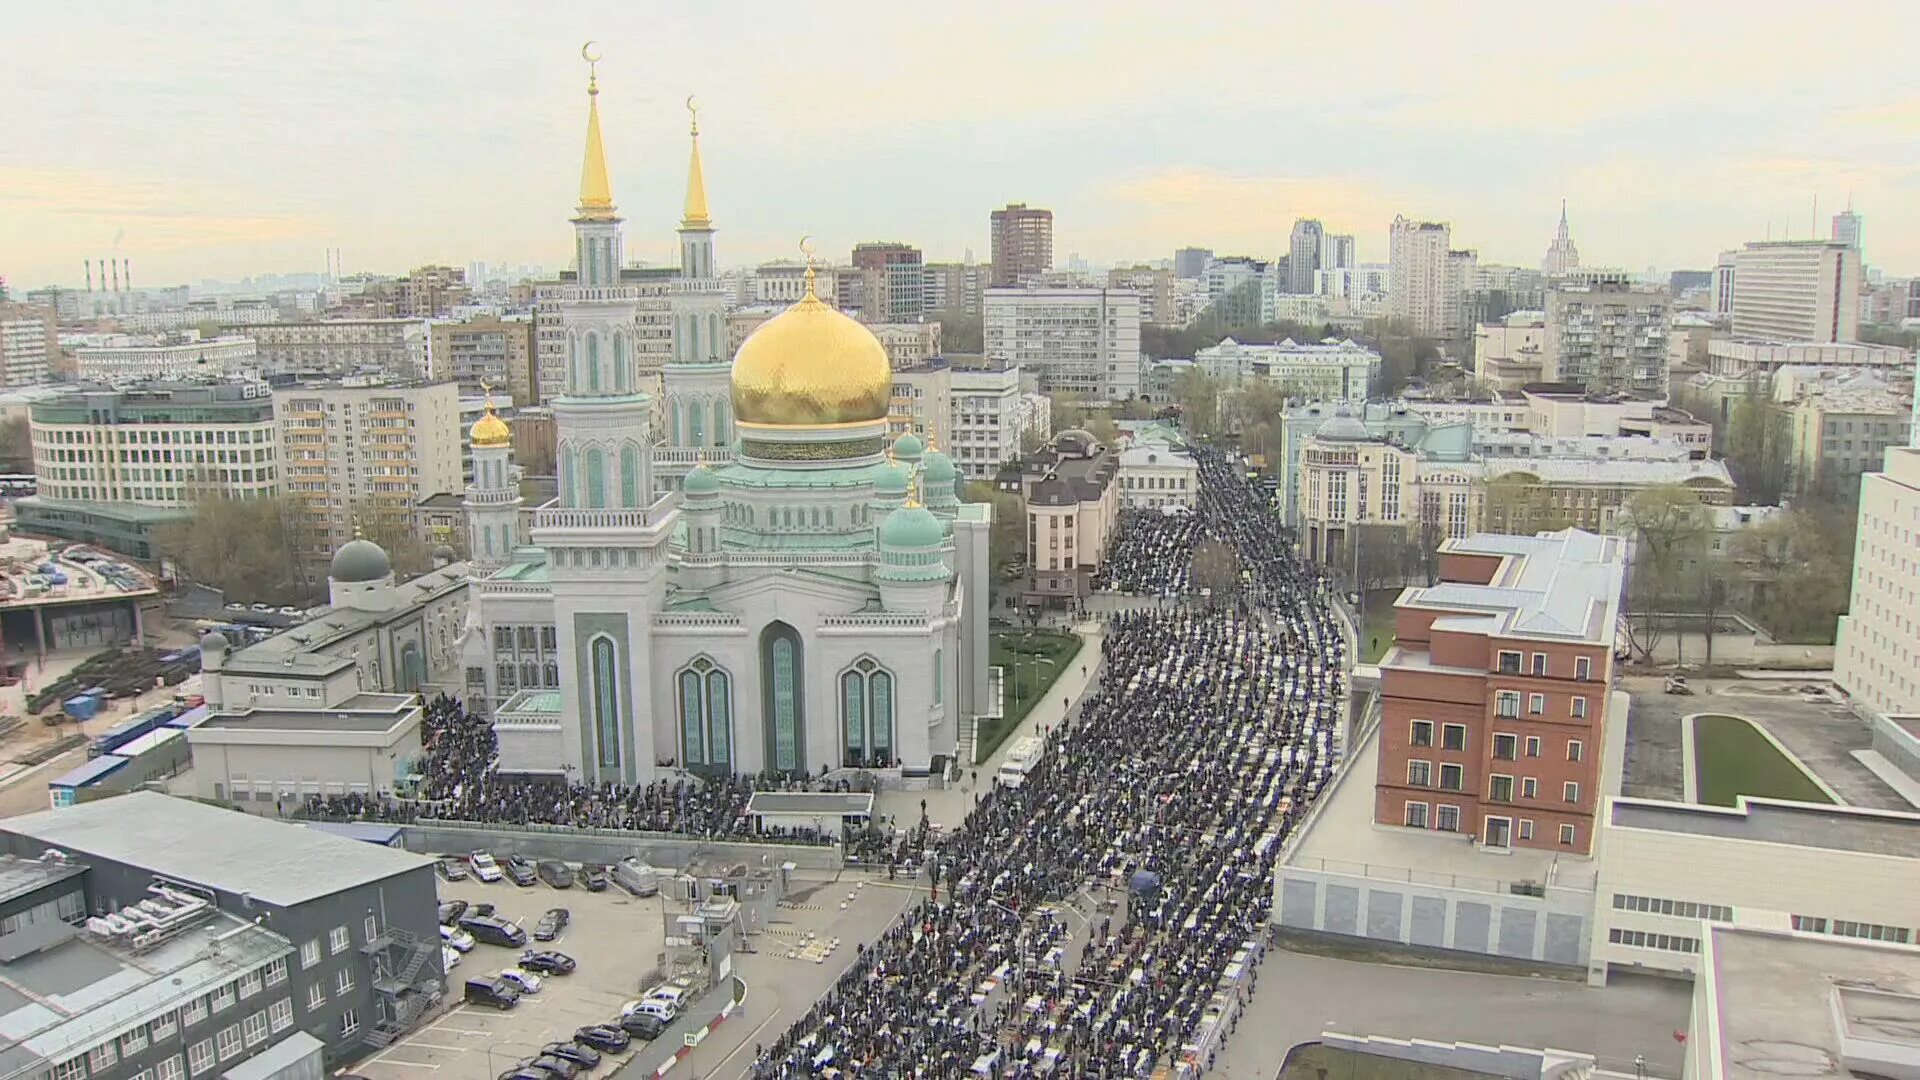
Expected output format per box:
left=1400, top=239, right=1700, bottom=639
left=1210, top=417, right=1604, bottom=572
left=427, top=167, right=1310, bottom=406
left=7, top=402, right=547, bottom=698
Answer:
left=273, top=379, right=461, bottom=559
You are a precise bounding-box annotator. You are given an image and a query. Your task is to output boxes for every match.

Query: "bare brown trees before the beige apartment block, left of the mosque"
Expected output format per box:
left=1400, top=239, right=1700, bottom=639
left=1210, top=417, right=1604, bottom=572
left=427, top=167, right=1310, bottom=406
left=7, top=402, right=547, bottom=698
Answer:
left=154, top=496, right=315, bottom=605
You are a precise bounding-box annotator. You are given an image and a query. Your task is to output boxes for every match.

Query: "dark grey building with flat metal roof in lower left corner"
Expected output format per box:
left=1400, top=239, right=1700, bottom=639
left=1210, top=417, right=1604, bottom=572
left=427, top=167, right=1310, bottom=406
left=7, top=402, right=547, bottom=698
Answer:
left=0, top=778, right=445, bottom=1060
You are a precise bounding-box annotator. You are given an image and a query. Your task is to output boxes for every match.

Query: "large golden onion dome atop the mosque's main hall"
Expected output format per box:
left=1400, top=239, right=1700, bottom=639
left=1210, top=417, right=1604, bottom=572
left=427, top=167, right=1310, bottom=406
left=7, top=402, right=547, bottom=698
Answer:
left=733, top=282, right=893, bottom=427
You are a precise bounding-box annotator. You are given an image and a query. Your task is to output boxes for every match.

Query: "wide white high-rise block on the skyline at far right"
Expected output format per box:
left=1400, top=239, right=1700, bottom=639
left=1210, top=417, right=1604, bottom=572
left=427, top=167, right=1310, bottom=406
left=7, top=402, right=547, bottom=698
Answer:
left=1734, top=240, right=1860, bottom=342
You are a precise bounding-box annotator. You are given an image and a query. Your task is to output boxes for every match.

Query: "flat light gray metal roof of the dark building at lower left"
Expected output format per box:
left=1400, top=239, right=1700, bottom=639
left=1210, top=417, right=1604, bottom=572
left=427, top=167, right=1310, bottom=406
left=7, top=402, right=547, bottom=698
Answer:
left=0, top=792, right=434, bottom=907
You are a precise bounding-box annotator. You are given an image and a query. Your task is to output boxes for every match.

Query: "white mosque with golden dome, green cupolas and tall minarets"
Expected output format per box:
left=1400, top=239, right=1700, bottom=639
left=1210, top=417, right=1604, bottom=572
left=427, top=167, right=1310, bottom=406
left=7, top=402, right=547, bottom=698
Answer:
left=459, top=58, right=991, bottom=784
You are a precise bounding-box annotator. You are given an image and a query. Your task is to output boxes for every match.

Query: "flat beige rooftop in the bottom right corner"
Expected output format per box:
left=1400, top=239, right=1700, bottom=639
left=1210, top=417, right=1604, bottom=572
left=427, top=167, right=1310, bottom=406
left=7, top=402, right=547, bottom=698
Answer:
left=1693, top=924, right=1920, bottom=1080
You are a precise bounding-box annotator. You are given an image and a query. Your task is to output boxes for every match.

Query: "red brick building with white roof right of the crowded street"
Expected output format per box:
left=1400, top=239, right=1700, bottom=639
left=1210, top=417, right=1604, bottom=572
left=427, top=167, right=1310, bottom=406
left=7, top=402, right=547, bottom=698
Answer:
left=1373, top=528, right=1626, bottom=855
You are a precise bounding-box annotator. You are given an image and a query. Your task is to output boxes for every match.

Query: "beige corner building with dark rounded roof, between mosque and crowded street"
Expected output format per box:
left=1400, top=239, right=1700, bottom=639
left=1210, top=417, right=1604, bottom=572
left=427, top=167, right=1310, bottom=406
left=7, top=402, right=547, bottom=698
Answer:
left=1020, top=429, right=1119, bottom=607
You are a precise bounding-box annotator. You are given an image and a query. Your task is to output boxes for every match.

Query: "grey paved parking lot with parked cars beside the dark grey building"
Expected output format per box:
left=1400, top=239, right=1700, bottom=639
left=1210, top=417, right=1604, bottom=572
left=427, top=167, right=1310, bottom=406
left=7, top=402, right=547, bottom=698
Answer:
left=353, top=864, right=664, bottom=1080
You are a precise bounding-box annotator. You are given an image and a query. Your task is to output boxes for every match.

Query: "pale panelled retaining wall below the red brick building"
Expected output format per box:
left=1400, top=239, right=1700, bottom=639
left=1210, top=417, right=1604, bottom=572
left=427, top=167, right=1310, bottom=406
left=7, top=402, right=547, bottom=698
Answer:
left=1279, top=865, right=1594, bottom=967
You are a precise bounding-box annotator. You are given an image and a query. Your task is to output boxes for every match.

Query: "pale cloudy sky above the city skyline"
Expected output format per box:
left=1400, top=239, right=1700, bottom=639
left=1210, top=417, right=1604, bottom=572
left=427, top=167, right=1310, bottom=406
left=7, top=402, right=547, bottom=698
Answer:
left=0, top=0, right=1920, bottom=288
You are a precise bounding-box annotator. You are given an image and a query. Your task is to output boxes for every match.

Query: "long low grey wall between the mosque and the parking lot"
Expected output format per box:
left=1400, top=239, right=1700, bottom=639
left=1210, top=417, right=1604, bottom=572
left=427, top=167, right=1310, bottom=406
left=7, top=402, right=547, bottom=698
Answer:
left=401, top=821, right=841, bottom=871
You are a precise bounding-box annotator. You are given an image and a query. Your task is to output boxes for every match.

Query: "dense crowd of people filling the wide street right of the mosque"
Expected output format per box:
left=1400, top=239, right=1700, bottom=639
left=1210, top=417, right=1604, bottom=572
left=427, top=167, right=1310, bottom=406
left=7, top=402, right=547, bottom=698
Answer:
left=753, top=448, right=1346, bottom=1080
